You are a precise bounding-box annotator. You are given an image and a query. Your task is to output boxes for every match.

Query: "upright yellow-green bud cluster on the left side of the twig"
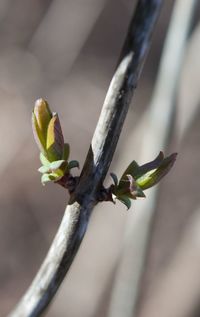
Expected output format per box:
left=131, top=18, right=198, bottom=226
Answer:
left=32, top=99, right=79, bottom=184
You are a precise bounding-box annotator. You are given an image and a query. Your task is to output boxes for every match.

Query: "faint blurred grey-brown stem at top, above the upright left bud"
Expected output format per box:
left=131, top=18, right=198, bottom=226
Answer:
left=30, top=0, right=106, bottom=78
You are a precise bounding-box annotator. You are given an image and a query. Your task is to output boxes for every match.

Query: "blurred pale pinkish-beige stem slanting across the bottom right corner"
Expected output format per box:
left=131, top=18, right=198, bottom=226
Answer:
left=140, top=208, right=200, bottom=317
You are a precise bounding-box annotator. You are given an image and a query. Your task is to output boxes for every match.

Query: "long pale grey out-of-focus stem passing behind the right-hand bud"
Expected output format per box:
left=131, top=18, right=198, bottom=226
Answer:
left=109, top=0, right=197, bottom=317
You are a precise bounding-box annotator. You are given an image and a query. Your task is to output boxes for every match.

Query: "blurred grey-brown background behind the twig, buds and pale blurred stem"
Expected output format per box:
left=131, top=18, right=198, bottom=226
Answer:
left=0, top=0, right=200, bottom=317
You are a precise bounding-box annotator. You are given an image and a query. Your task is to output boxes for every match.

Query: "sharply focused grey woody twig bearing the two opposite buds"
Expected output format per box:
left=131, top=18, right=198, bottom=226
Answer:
left=10, top=0, right=162, bottom=317
